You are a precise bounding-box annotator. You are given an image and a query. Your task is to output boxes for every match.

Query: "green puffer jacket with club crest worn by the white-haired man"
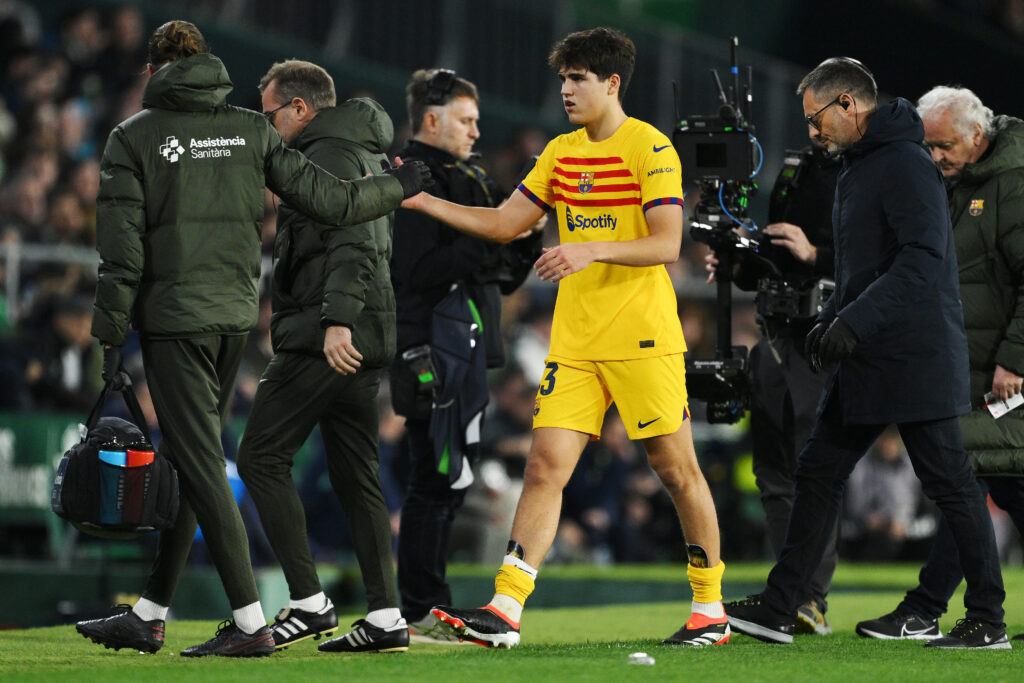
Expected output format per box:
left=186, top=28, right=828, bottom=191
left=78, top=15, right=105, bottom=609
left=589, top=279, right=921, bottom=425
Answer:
left=946, top=117, right=1024, bottom=475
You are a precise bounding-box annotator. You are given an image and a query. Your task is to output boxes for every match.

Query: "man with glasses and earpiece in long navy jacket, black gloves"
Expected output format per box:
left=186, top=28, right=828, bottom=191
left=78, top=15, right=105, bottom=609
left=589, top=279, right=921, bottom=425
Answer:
left=726, top=57, right=1010, bottom=648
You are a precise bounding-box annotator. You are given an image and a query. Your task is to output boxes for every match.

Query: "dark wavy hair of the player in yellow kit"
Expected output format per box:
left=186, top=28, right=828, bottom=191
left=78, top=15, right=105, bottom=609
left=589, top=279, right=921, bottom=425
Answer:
left=548, top=27, right=637, bottom=101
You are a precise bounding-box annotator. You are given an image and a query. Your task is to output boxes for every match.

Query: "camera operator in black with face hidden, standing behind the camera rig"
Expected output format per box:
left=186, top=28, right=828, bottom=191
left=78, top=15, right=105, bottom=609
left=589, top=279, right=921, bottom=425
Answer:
left=706, top=144, right=841, bottom=635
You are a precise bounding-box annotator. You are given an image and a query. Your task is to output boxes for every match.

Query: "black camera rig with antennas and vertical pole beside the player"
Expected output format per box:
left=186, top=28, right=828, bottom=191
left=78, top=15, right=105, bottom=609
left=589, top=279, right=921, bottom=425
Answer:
left=672, top=37, right=765, bottom=423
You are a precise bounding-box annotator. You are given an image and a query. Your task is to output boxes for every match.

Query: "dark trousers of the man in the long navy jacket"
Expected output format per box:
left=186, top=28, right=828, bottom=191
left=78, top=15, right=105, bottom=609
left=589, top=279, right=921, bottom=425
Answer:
left=764, top=391, right=1006, bottom=624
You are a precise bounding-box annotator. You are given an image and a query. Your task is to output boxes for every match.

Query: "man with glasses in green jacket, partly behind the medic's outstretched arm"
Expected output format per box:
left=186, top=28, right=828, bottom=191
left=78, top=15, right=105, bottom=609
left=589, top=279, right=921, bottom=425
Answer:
left=238, top=59, right=409, bottom=652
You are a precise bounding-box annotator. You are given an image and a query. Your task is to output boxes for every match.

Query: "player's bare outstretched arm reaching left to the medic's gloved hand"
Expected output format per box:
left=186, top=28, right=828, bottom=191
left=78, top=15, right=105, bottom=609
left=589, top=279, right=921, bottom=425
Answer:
left=401, top=191, right=544, bottom=243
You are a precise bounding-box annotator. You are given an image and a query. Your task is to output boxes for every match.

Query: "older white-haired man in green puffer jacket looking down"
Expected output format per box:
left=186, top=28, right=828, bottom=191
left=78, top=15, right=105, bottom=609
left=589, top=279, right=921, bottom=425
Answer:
left=857, top=86, right=1024, bottom=640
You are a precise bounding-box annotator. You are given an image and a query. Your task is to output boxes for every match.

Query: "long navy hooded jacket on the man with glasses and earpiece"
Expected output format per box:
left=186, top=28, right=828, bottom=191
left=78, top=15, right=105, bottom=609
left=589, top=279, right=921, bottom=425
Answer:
left=818, top=98, right=971, bottom=424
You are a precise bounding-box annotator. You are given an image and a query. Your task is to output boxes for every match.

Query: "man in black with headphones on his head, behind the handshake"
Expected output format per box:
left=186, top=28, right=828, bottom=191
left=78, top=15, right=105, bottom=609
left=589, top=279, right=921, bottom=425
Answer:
left=391, top=69, right=543, bottom=642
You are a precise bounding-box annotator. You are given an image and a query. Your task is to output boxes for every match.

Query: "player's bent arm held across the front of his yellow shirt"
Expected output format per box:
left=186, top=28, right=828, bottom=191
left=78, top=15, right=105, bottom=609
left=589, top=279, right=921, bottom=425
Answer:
left=534, top=204, right=683, bottom=282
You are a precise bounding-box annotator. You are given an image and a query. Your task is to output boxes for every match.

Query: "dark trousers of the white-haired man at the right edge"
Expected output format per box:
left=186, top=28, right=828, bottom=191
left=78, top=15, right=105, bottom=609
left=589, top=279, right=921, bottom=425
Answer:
left=899, top=477, right=1024, bottom=618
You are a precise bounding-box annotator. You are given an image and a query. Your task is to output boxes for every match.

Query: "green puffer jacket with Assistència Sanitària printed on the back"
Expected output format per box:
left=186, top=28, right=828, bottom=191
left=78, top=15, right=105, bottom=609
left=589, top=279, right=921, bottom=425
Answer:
left=92, top=54, right=402, bottom=345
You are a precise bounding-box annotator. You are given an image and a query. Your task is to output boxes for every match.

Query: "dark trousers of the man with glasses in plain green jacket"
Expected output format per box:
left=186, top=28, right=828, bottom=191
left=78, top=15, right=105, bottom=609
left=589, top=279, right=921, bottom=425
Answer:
left=238, top=353, right=398, bottom=611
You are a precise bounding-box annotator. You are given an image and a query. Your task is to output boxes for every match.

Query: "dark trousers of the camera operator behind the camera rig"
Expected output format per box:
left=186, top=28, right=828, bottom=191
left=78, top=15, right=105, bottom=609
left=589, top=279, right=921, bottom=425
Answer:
left=751, top=329, right=839, bottom=611
